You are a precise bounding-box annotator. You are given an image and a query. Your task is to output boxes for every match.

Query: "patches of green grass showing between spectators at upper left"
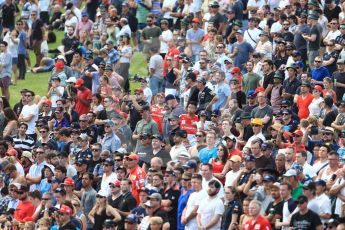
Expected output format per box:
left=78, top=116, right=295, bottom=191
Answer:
left=10, top=31, right=147, bottom=106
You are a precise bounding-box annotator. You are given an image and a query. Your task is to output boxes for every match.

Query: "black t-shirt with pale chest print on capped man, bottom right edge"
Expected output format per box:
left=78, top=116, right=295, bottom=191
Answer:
left=290, top=210, right=322, bottom=230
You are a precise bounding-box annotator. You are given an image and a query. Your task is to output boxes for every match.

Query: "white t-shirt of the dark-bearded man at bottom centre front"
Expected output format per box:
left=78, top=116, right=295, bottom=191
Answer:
left=198, top=197, right=224, bottom=230
